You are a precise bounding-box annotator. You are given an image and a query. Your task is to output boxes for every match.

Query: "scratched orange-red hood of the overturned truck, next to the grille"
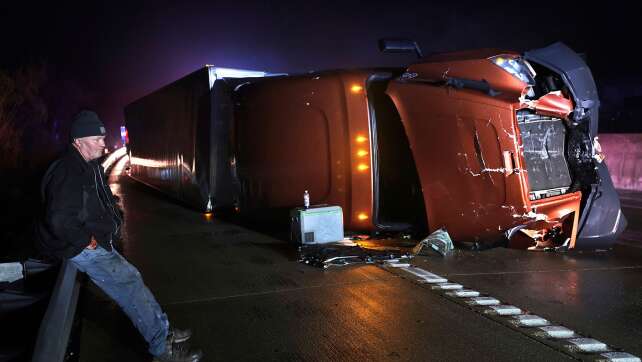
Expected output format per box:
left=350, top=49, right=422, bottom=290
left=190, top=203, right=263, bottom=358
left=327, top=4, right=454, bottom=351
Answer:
left=387, top=79, right=527, bottom=242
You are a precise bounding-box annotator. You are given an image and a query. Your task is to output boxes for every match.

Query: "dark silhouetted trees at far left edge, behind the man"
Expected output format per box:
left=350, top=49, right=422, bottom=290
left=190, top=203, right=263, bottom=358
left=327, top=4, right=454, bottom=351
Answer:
left=0, top=65, right=56, bottom=259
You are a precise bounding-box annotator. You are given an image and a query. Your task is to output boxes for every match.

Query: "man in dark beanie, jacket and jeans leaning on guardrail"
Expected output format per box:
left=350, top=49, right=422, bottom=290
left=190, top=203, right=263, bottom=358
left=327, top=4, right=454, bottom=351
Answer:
left=37, top=111, right=202, bottom=362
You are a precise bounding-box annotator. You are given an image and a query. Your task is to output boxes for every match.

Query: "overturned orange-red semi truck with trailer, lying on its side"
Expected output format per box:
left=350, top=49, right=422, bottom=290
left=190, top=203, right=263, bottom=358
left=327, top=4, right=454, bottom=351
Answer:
left=125, top=42, right=626, bottom=248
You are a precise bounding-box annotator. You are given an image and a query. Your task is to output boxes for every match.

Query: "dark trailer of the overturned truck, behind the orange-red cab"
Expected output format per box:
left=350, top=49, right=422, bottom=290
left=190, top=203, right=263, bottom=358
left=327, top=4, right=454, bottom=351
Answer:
left=125, top=66, right=265, bottom=211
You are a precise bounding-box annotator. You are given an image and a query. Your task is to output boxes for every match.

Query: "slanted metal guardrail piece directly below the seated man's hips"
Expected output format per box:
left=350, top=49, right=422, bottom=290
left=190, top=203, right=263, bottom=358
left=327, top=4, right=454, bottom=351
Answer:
left=31, top=260, right=80, bottom=362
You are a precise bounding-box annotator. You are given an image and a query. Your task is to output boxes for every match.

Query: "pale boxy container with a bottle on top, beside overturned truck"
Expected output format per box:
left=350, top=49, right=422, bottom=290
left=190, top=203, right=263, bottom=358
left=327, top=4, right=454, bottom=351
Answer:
left=290, top=206, right=343, bottom=244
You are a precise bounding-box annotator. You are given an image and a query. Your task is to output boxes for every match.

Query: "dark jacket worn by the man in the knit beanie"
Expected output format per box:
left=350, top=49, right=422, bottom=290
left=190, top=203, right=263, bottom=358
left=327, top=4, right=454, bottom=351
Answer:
left=36, top=146, right=122, bottom=260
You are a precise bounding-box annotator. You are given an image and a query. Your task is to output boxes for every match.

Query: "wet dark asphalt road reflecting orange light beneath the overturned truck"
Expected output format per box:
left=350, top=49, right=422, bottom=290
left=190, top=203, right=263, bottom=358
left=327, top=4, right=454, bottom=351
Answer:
left=80, top=157, right=642, bottom=362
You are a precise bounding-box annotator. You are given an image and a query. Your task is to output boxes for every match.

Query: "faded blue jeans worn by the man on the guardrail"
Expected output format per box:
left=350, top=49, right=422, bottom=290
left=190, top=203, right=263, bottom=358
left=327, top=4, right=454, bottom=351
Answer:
left=70, top=247, right=169, bottom=356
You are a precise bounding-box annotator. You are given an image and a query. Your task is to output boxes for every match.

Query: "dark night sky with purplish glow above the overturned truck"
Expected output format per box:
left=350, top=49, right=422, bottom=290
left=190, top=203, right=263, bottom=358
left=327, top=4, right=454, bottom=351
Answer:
left=0, top=0, right=642, bottom=139
